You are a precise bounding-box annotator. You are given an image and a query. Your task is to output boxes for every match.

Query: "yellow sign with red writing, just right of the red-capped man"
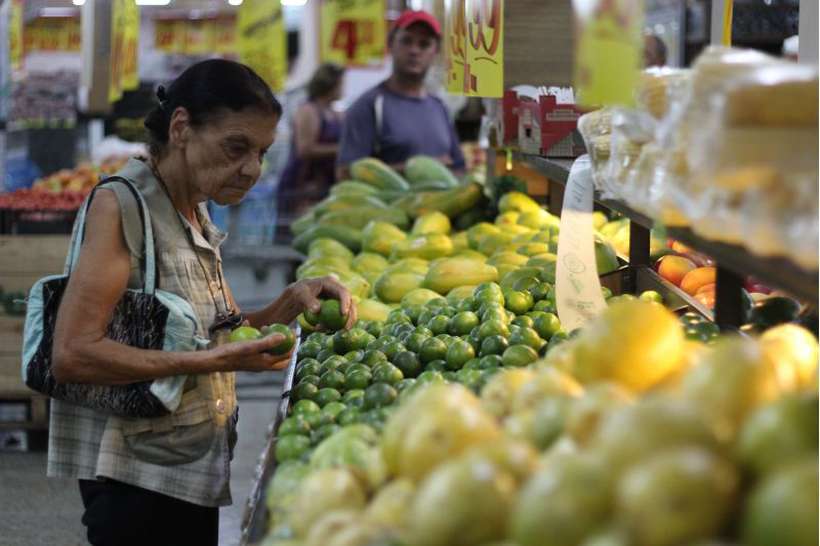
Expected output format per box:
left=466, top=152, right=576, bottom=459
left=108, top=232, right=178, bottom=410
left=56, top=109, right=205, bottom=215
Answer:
left=444, top=0, right=504, bottom=97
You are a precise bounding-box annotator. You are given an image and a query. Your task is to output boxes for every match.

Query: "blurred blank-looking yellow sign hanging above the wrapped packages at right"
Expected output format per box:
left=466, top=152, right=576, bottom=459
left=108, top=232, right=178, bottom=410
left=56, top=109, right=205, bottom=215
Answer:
left=572, top=0, right=644, bottom=106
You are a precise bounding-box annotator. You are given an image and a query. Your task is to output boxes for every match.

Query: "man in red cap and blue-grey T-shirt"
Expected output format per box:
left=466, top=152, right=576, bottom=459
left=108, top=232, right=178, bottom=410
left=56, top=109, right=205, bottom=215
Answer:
left=337, top=11, right=464, bottom=176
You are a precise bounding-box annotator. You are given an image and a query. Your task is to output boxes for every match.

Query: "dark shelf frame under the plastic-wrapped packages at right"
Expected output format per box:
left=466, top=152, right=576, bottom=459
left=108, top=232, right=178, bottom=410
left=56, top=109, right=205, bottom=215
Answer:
left=515, top=153, right=818, bottom=330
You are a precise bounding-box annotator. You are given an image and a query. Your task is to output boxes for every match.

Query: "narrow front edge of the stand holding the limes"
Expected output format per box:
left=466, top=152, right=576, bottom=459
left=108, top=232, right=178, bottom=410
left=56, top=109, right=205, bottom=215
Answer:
left=240, top=326, right=302, bottom=546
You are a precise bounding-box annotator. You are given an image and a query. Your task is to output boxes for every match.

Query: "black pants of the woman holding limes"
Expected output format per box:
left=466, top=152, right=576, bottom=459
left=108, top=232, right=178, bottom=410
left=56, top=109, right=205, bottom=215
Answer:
left=80, top=480, right=219, bottom=546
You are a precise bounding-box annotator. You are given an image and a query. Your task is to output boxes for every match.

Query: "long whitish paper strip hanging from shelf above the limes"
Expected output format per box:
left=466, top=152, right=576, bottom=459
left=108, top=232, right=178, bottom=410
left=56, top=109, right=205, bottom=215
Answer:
left=555, top=155, right=606, bottom=332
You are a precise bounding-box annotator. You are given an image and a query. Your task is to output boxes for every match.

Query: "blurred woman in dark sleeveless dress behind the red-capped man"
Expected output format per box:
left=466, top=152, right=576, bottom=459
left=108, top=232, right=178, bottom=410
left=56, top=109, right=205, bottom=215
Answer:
left=277, top=63, right=345, bottom=218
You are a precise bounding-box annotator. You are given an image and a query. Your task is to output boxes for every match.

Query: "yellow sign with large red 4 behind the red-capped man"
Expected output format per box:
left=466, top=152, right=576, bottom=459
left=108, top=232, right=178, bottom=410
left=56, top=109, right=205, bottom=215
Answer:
left=320, top=0, right=386, bottom=66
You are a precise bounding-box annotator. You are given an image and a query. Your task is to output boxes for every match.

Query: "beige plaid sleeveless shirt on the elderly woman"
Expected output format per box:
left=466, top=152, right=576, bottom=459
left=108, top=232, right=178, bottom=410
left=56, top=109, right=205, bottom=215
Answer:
left=47, top=159, right=237, bottom=506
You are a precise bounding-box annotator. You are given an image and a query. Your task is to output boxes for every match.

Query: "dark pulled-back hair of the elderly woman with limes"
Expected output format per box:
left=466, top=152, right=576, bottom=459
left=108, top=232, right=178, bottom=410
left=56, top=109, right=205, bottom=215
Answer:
left=145, top=59, right=282, bottom=156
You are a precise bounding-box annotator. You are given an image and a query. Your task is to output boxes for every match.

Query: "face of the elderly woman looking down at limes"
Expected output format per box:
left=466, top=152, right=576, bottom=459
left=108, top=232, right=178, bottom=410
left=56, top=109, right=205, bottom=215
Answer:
left=173, top=109, right=279, bottom=205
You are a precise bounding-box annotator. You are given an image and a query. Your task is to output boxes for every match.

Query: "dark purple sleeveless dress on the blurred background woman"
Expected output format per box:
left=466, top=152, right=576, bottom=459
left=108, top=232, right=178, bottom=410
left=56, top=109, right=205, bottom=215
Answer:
left=279, top=102, right=342, bottom=198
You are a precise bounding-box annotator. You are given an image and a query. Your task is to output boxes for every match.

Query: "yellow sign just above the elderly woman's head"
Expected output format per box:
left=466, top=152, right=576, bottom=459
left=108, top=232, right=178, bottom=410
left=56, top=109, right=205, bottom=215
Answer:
left=236, top=0, right=287, bottom=91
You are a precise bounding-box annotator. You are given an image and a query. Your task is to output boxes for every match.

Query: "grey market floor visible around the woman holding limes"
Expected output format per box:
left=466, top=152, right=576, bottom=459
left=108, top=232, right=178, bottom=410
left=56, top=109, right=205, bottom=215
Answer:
left=0, top=256, right=294, bottom=546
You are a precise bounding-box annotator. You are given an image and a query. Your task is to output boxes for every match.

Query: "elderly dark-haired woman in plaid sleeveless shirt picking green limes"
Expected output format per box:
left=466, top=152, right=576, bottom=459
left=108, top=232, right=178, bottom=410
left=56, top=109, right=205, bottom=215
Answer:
left=48, top=60, right=356, bottom=546
